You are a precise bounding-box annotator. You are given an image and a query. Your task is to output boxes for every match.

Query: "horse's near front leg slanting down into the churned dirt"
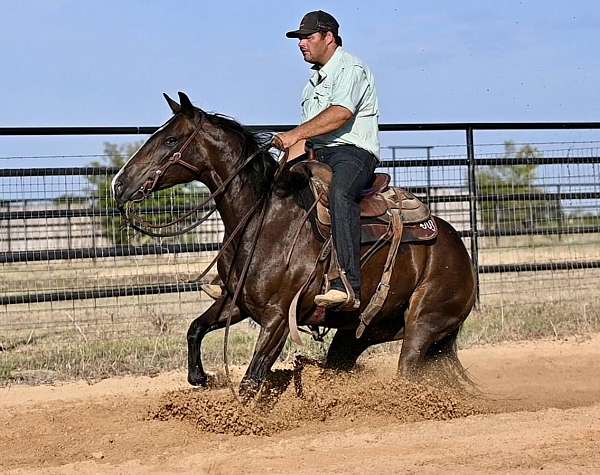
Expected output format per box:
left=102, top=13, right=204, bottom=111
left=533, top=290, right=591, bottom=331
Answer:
left=240, top=311, right=289, bottom=399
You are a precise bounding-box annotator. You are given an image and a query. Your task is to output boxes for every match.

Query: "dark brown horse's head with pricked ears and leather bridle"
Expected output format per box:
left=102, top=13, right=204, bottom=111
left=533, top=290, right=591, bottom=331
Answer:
left=112, top=92, right=206, bottom=209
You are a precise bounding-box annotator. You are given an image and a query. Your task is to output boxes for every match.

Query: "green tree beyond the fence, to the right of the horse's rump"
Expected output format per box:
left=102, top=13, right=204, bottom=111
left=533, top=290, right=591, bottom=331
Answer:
left=477, top=142, right=562, bottom=230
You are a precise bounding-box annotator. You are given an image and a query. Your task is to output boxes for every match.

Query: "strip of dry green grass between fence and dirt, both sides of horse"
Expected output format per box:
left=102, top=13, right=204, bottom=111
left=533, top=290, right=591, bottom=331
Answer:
left=0, top=302, right=600, bottom=385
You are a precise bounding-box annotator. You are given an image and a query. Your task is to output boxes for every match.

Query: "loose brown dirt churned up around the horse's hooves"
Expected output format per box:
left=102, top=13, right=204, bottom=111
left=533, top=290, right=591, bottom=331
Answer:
left=150, top=366, right=489, bottom=436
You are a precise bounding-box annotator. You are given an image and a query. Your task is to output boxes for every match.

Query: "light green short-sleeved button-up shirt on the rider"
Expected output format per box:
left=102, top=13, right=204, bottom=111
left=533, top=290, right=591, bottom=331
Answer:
left=302, top=47, right=379, bottom=158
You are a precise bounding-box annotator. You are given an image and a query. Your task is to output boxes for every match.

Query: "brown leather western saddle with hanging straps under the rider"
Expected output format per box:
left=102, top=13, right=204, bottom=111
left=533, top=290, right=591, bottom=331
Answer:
left=288, top=160, right=438, bottom=345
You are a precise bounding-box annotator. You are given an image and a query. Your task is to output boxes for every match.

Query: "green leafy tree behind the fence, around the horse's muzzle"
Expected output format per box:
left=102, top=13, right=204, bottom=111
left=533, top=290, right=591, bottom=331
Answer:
left=87, top=141, right=207, bottom=245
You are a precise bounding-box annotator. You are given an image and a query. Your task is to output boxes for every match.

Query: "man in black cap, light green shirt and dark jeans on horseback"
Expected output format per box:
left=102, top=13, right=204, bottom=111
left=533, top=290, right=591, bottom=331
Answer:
left=203, top=10, right=379, bottom=308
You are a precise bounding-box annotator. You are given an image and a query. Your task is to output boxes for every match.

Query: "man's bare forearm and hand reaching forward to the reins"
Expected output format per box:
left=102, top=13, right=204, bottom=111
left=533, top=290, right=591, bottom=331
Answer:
left=273, top=106, right=353, bottom=152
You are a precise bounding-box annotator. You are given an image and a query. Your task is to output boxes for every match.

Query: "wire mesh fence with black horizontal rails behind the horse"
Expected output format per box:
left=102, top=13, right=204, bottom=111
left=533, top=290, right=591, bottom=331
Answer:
left=0, top=126, right=600, bottom=344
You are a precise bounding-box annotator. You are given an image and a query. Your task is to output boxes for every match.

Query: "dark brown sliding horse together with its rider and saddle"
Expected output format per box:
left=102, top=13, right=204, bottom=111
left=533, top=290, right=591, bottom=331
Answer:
left=112, top=11, right=476, bottom=397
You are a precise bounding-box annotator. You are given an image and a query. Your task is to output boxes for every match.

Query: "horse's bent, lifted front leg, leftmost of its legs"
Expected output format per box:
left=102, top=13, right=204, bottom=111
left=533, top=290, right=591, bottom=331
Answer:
left=187, top=297, right=245, bottom=387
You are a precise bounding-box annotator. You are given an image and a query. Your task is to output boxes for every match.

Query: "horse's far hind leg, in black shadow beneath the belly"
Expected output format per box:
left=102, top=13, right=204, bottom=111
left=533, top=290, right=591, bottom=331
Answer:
left=325, top=317, right=404, bottom=371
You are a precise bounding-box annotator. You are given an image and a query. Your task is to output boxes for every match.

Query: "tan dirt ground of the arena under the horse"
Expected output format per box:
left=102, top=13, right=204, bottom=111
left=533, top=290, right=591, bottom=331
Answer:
left=0, top=335, right=600, bottom=474
